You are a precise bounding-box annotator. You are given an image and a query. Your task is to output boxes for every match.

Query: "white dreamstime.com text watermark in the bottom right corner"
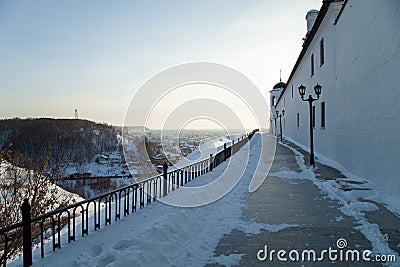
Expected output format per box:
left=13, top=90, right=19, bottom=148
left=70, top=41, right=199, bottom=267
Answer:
left=257, top=238, right=396, bottom=262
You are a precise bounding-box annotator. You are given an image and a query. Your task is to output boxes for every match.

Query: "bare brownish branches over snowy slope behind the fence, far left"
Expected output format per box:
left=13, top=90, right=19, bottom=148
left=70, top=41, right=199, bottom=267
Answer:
left=0, top=147, right=73, bottom=264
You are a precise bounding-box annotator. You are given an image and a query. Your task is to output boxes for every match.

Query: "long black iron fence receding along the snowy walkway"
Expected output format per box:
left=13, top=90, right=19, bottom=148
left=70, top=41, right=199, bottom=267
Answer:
left=0, top=129, right=258, bottom=267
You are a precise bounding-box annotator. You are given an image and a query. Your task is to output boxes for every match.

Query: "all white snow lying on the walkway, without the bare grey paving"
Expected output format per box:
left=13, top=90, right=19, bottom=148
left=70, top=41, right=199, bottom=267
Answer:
left=7, top=134, right=399, bottom=266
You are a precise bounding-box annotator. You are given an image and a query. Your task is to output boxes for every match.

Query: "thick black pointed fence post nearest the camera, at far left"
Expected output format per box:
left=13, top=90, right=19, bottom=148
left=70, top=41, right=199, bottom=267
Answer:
left=21, top=198, right=32, bottom=267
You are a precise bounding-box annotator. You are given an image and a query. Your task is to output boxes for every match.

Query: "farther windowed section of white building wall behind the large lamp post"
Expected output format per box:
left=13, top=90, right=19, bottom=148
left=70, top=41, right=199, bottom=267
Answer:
left=277, top=3, right=341, bottom=160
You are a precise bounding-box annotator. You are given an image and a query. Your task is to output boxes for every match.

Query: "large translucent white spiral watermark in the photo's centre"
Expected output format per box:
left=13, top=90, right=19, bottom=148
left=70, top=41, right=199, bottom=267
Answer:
left=122, top=62, right=276, bottom=207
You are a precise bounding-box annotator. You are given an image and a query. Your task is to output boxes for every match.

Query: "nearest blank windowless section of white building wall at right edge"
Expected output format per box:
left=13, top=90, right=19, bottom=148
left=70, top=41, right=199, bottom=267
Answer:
left=336, top=0, right=400, bottom=196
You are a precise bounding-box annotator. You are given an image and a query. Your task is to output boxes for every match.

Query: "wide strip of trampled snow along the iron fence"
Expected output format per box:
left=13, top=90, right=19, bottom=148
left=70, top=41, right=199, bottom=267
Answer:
left=24, top=134, right=261, bottom=266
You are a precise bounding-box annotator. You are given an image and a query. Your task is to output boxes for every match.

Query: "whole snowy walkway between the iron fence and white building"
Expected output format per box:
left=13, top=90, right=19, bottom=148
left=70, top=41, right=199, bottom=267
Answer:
left=9, top=134, right=400, bottom=266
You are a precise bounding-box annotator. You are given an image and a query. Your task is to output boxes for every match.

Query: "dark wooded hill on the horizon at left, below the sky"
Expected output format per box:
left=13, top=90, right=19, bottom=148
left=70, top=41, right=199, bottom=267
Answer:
left=0, top=118, right=119, bottom=169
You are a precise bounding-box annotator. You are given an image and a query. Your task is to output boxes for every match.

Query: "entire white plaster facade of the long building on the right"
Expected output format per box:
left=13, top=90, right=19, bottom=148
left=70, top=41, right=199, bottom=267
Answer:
left=271, top=0, right=400, bottom=197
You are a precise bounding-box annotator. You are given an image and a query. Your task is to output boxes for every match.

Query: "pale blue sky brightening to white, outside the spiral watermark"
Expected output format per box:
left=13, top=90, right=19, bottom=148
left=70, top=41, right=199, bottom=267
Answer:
left=0, top=0, right=322, bottom=128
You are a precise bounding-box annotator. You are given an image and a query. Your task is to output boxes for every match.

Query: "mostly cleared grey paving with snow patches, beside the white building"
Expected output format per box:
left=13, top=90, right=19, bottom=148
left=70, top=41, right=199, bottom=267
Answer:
left=207, top=139, right=400, bottom=266
